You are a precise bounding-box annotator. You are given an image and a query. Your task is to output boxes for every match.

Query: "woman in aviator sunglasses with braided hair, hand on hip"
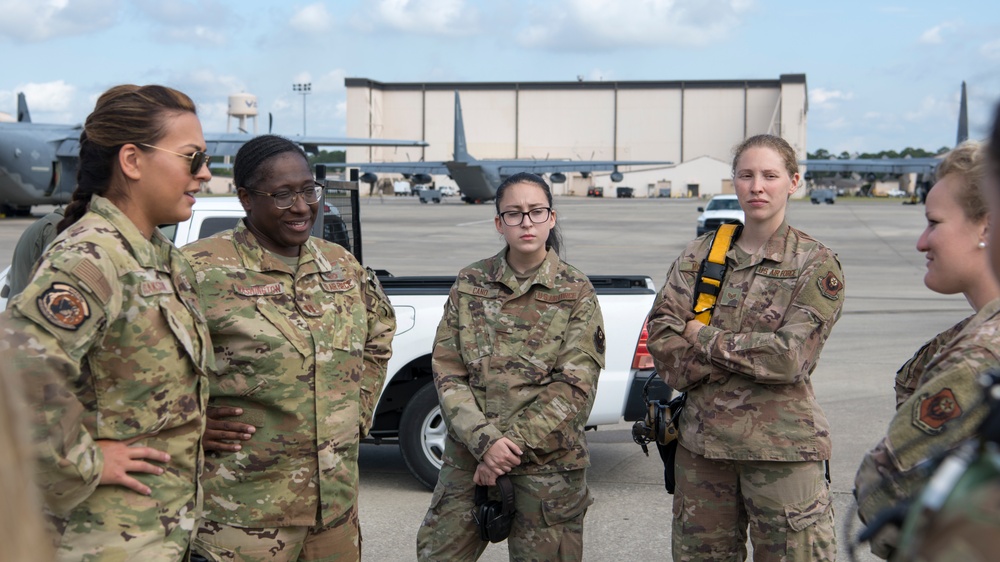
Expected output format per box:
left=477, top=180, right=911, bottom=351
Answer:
left=0, top=85, right=211, bottom=560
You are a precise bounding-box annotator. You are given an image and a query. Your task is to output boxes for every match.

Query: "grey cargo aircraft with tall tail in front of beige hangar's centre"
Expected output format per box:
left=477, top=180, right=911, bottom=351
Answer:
left=338, top=91, right=672, bottom=203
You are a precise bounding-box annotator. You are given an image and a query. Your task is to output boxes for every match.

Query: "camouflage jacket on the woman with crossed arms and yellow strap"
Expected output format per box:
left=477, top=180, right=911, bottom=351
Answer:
left=647, top=223, right=844, bottom=461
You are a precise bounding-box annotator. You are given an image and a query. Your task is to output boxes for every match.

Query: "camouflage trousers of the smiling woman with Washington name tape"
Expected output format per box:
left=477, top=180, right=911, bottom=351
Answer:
left=192, top=504, right=361, bottom=562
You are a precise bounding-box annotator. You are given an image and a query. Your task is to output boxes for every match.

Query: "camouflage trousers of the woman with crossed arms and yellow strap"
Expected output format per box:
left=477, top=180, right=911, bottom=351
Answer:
left=671, top=446, right=837, bottom=562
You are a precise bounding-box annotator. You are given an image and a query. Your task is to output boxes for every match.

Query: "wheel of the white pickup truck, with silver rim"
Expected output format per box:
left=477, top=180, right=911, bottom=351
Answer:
left=399, top=383, right=448, bottom=490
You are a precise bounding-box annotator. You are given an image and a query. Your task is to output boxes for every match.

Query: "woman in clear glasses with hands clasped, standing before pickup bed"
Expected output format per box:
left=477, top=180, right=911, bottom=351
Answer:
left=417, top=173, right=605, bottom=561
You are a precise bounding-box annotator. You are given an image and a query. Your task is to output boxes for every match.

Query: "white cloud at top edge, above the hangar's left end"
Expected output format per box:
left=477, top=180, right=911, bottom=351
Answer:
left=355, top=0, right=481, bottom=36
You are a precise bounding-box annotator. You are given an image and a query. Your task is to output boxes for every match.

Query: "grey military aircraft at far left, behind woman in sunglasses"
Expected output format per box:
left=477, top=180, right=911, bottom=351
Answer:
left=0, top=93, right=427, bottom=215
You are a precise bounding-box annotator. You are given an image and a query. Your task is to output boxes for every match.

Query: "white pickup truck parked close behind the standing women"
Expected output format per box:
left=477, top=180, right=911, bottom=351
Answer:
left=0, top=197, right=656, bottom=488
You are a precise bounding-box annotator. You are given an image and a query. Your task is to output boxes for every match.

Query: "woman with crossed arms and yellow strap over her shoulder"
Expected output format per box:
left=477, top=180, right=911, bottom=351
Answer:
left=647, top=135, right=844, bottom=561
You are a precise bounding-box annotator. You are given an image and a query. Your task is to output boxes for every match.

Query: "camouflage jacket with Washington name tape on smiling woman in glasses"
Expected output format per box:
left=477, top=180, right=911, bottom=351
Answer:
left=183, top=221, right=396, bottom=527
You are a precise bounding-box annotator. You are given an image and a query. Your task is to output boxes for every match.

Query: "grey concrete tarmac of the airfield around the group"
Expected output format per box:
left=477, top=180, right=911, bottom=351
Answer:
left=0, top=197, right=972, bottom=562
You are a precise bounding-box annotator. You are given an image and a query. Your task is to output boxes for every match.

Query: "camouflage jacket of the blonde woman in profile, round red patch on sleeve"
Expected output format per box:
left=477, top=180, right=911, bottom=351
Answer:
left=854, top=299, right=1000, bottom=522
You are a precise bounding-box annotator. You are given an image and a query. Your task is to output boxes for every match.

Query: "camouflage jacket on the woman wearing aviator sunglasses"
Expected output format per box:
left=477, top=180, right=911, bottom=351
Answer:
left=0, top=196, right=211, bottom=560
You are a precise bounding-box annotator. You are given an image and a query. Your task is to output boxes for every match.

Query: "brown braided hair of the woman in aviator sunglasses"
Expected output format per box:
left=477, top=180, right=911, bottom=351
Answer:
left=56, top=84, right=196, bottom=232
